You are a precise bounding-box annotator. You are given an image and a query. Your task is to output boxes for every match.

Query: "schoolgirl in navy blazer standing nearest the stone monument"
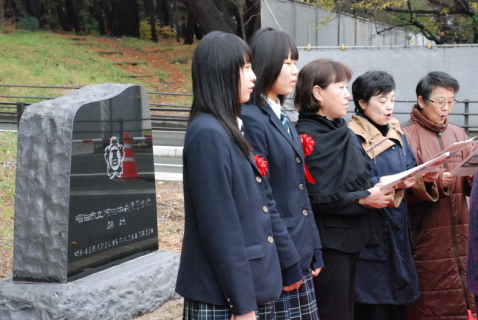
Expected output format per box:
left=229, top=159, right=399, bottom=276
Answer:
left=176, top=32, right=300, bottom=319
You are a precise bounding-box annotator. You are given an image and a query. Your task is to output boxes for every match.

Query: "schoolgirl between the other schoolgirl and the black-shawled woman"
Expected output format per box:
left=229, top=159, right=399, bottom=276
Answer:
left=241, top=28, right=324, bottom=320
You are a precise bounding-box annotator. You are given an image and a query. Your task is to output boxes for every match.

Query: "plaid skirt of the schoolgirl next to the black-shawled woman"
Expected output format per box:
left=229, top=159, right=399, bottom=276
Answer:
left=273, top=270, right=319, bottom=320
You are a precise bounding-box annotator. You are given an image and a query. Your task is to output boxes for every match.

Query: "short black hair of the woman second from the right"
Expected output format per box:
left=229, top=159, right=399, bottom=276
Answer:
left=352, top=70, right=395, bottom=113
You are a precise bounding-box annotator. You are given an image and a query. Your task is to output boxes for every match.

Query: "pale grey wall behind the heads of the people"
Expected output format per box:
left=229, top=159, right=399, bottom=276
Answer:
left=262, top=0, right=478, bottom=131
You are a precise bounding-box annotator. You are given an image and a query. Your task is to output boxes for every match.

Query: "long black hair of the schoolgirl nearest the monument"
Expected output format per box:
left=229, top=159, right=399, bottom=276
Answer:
left=189, top=31, right=252, bottom=157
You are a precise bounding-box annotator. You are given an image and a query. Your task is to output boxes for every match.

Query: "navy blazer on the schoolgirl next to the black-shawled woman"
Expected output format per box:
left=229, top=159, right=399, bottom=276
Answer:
left=241, top=104, right=323, bottom=270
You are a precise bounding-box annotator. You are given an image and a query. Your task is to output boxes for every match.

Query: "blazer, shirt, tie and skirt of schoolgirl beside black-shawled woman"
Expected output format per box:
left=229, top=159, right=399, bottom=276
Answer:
left=241, top=99, right=324, bottom=320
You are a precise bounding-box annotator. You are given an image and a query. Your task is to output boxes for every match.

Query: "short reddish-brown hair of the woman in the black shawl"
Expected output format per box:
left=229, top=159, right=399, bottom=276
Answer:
left=294, top=58, right=352, bottom=113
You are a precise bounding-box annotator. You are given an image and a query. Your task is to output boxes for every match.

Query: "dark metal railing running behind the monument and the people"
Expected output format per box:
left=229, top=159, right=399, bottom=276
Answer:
left=0, top=84, right=478, bottom=133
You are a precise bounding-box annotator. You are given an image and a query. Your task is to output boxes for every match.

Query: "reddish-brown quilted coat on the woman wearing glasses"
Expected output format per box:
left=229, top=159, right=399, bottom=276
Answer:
left=402, top=107, right=474, bottom=320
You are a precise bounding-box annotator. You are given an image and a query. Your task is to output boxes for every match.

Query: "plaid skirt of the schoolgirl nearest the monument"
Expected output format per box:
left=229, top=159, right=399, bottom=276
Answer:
left=183, top=298, right=274, bottom=320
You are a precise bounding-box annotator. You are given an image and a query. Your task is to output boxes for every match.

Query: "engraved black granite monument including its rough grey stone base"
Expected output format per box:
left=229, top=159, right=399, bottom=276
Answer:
left=0, top=84, right=179, bottom=320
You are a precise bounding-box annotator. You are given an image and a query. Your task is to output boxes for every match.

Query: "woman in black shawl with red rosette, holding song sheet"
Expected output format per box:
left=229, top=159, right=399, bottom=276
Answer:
left=294, top=59, right=393, bottom=320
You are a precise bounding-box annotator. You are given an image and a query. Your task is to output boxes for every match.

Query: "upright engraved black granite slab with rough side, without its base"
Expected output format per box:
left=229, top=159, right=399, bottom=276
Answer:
left=13, top=84, right=158, bottom=283
